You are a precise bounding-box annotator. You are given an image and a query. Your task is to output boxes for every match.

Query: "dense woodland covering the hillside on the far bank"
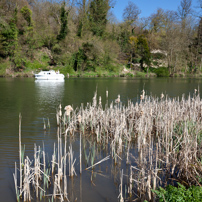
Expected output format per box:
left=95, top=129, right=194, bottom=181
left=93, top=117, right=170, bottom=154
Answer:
left=0, top=0, right=202, bottom=76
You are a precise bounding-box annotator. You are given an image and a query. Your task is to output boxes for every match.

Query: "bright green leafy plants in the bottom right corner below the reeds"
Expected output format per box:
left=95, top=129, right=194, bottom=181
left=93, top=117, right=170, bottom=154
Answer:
left=152, top=183, right=202, bottom=202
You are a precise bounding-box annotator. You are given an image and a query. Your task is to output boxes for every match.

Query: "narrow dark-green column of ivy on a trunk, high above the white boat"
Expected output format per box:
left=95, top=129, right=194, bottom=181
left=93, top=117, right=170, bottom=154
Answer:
left=57, top=3, right=68, bottom=41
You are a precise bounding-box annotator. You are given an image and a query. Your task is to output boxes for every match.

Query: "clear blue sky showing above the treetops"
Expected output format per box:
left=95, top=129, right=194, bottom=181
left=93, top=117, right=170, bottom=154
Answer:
left=113, top=0, right=198, bottom=21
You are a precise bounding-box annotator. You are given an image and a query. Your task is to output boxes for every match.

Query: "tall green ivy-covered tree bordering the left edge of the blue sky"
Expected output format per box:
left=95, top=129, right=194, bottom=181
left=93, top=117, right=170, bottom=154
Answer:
left=89, top=0, right=110, bottom=36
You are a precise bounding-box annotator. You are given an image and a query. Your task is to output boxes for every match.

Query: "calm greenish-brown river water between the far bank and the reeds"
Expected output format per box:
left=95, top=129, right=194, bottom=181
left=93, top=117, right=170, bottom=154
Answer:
left=0, top=78, right=202, bottom=202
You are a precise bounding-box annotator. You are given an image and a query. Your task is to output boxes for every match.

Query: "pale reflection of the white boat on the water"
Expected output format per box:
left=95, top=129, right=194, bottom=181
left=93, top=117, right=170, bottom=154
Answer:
left=35, top=80, right=65, bottom=105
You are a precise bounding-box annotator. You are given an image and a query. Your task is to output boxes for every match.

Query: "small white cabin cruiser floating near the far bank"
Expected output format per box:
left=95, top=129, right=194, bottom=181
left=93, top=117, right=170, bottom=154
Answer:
left=34, top=70, right=65, bottom=80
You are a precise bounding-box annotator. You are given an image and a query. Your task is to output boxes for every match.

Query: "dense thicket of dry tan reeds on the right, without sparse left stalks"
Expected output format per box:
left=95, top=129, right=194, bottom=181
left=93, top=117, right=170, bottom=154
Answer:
left=61, top=90, right=202, bottom=200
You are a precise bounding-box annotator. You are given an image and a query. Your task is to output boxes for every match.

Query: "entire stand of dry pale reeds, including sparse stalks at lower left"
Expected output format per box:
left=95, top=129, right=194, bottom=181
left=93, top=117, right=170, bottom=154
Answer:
left=13, top=90, right=202, bottom=201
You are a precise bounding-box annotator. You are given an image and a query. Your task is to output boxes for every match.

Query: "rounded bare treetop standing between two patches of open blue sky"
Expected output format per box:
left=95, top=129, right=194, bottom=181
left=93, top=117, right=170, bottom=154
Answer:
left=123, top=1, right=141, bottom=25
